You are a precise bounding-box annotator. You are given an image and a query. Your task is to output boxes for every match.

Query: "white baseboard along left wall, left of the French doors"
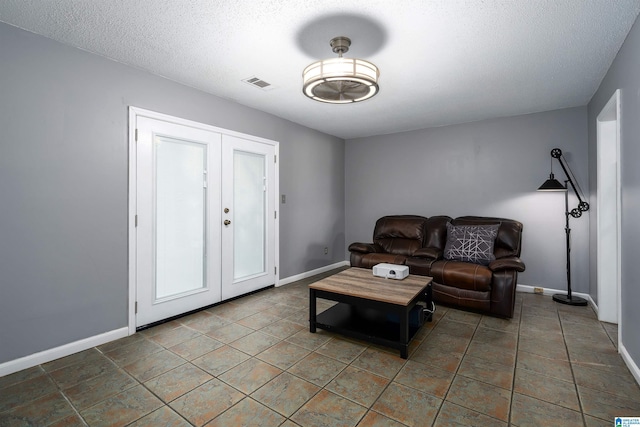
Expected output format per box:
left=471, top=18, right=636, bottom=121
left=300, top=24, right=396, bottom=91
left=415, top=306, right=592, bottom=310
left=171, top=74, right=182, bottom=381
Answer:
left=0, top=327, right=129, bottom=377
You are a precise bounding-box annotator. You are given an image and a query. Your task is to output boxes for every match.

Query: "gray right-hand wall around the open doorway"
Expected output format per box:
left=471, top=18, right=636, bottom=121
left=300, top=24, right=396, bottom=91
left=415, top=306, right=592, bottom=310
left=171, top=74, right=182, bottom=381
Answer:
left=588, top=15, right=640, bottom=365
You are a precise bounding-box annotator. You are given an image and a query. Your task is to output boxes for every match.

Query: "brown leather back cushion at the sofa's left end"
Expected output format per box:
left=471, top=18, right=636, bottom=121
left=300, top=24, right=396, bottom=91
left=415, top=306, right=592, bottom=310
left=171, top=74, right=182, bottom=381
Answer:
left=373, top=215, right=427, bottom=256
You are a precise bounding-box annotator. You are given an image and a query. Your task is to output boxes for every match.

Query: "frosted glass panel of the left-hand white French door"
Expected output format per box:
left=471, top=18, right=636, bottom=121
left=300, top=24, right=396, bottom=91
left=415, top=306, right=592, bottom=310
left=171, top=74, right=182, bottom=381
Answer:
left=154, top=136, right=207, bottom=300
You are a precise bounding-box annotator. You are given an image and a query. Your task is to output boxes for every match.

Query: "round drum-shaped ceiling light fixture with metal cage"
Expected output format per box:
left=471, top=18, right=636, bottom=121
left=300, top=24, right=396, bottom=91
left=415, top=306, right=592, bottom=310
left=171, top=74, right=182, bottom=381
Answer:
left=302, top=37, right=380, bottom=104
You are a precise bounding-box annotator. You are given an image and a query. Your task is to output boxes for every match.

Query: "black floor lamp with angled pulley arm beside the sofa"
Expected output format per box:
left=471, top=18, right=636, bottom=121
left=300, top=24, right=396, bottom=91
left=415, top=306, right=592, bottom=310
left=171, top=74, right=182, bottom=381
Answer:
left=538, top=148, right=589, bottom=305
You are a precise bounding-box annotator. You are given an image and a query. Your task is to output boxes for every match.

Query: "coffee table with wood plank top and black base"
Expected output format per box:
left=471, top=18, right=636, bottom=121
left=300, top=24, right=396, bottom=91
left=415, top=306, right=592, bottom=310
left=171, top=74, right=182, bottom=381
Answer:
left=309, top=268, right=433, bottom=359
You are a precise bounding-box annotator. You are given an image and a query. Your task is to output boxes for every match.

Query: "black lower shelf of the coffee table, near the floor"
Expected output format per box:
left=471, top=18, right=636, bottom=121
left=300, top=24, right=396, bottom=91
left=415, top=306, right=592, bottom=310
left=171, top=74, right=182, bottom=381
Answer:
left=311, top=303, right=420, bottom=359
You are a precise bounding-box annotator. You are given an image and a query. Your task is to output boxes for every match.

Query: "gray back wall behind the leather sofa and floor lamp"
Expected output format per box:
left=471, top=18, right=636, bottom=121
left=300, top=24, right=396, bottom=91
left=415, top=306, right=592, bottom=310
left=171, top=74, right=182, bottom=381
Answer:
left=345, top=107, right=589, bottom=293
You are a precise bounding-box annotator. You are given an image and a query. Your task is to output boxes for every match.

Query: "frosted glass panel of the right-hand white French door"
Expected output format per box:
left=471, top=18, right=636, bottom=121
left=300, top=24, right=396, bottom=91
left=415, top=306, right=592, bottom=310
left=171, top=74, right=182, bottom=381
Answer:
left=233, top=151, right=266, bottom=281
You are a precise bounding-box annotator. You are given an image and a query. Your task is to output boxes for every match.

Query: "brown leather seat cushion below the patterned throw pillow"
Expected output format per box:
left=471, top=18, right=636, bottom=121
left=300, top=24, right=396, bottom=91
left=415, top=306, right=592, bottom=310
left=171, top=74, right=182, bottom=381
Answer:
left=429, top=260, right=493, bottom=292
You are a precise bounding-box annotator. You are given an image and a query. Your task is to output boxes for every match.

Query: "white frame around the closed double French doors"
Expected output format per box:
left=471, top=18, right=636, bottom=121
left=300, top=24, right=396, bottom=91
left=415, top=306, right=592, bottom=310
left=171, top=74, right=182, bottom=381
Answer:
left=128, top=106, right=280, bottom=335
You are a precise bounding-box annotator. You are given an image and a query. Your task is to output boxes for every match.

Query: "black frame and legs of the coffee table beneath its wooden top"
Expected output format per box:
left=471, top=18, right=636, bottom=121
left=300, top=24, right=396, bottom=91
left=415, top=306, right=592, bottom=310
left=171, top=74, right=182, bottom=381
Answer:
left=309, top=283, right=433, bottom=359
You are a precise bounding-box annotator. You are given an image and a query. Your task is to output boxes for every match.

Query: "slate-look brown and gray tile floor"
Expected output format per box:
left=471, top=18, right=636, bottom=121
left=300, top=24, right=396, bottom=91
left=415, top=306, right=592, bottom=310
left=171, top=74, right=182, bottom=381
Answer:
left=0, top=270, right=640, bottom=427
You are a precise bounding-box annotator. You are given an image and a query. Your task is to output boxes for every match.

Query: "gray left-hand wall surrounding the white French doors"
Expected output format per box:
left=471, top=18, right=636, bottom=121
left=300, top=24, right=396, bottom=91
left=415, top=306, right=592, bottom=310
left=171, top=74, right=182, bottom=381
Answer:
left=0, top=24, right=345, bottom=363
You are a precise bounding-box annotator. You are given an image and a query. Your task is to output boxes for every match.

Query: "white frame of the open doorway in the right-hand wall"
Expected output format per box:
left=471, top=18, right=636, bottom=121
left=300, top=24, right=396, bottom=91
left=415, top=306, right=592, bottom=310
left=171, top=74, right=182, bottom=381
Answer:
left=596, top=89, right=622, bottom=334
